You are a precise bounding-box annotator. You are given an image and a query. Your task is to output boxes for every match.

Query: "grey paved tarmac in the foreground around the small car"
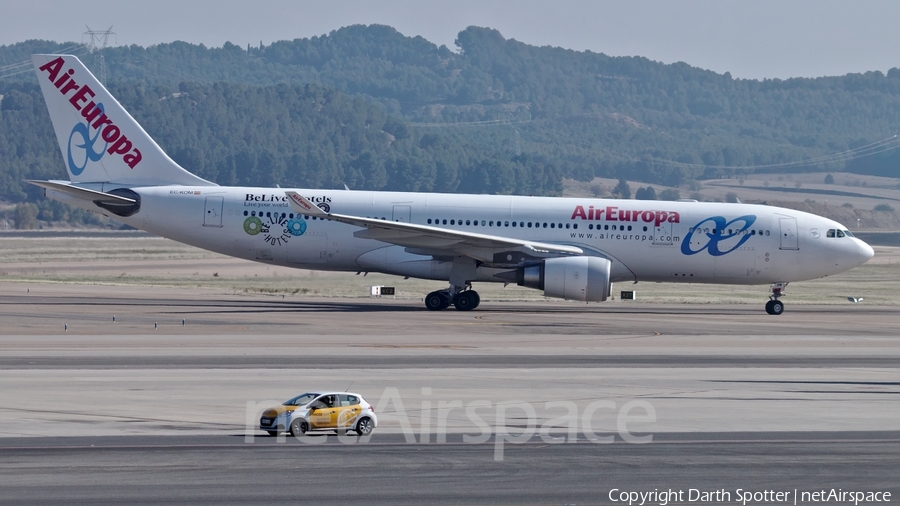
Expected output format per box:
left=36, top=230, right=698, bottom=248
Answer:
left=0, top=283, right=900, bottom=504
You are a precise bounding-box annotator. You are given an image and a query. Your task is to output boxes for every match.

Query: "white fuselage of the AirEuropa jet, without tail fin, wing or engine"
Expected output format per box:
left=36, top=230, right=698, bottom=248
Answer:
left=86, top=186, right=872, bottom=284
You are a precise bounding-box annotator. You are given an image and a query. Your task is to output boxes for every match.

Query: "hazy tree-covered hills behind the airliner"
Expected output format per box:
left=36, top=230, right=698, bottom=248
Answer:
left=0, top=25, right=900, bottom=225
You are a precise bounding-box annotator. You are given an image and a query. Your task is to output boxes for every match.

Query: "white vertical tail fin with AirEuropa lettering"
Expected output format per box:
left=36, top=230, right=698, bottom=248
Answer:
left=31, top=54, right=215, bottom=186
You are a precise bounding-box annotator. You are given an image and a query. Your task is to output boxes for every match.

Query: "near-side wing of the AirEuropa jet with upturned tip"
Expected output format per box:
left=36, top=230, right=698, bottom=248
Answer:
left=285, top=191, right=584, bottom=265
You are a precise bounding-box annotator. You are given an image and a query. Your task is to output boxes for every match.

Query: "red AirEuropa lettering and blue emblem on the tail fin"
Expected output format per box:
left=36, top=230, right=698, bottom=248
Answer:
left=39, top=57, right=142, bottom=176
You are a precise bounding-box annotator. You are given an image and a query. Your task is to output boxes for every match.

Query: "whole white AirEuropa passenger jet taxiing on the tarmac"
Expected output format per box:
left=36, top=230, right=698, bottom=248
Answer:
left=29, top=55, right=873, bottom=314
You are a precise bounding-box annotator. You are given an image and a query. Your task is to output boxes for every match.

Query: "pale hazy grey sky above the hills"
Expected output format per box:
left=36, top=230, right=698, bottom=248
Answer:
left=0, top=0, right=900, bottom=78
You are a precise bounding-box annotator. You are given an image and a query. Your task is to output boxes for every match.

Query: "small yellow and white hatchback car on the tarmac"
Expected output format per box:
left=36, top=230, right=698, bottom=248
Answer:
left=259, top=392, right=378, bottom=436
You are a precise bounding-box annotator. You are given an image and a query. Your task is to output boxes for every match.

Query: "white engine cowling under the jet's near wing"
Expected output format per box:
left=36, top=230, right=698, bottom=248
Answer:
left=516, top=256, right=611, bottom=302
